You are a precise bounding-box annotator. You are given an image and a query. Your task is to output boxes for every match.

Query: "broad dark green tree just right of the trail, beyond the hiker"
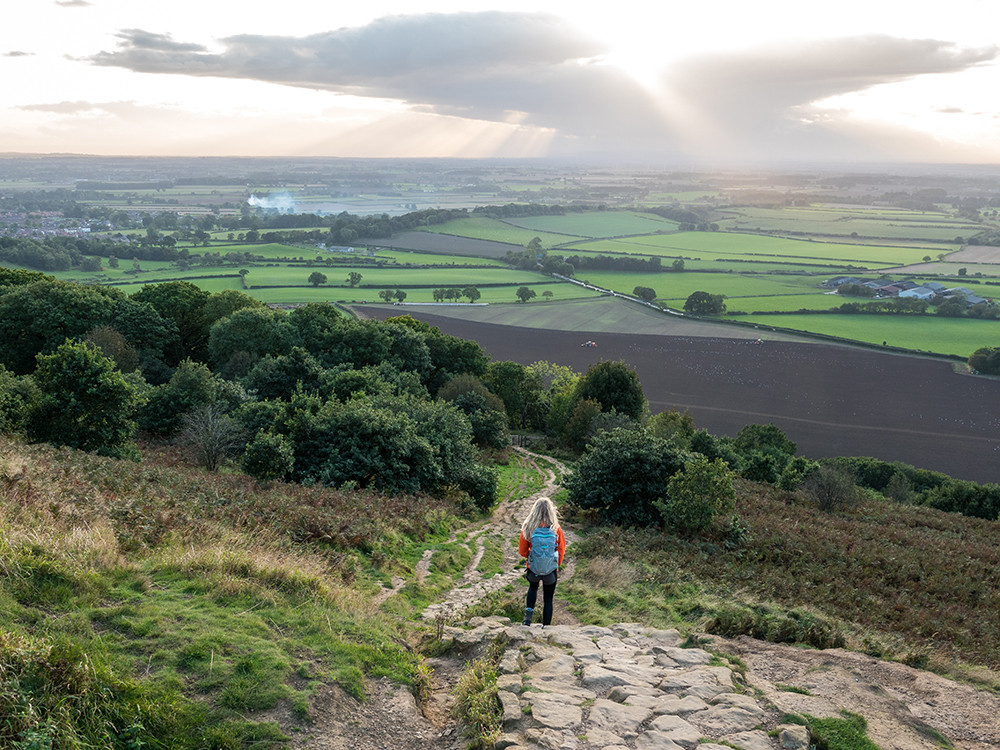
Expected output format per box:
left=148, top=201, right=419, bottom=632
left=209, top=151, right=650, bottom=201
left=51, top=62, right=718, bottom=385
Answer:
left=563, top=429, right=691, bottom=526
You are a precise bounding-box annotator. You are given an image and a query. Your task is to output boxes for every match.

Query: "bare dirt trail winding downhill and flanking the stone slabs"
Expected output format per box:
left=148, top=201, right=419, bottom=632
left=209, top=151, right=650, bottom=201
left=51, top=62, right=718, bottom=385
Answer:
left=293, top=448, right=1000, bottom=750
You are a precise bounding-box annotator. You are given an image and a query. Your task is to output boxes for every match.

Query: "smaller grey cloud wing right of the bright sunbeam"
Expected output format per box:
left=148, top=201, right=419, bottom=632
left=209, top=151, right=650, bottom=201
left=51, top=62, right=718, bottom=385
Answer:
left=664, top=35, right=998, bottom=158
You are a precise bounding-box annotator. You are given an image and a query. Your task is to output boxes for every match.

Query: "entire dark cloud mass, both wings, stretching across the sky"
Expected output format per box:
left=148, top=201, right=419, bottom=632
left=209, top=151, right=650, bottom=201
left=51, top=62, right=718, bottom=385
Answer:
left=90, top=12, right=997, bottom=162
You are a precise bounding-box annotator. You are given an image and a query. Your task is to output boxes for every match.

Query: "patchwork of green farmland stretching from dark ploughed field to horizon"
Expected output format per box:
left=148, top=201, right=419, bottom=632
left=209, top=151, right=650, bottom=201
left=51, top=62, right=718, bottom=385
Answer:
left=5, top=162, right=1000, bottom=356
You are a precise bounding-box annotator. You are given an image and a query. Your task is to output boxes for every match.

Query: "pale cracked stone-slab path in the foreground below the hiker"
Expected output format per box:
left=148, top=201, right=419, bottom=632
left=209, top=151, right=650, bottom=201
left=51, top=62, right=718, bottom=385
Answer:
left=446, top=617, right=809, bottom=750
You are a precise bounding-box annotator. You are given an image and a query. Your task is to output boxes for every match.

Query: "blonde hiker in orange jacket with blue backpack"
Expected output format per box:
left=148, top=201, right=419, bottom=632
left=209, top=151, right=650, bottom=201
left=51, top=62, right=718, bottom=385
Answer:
left=517, top=497, right=566, bottom=627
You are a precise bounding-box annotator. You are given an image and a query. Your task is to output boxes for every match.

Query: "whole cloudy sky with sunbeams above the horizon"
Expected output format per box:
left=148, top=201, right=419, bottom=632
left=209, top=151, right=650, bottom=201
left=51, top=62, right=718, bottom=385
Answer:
left=0, top=0, right=1000, bottom=167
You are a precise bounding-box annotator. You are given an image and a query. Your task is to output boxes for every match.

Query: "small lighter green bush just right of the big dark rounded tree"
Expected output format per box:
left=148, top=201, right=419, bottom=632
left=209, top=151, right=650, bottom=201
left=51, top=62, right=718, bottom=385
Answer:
left=654, top=456, right=736, bottom=534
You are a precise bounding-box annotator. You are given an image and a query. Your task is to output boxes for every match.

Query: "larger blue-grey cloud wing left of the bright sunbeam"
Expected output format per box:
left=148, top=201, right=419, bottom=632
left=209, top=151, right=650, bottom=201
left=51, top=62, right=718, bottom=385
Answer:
left=90, top=12, right=656, bottom=145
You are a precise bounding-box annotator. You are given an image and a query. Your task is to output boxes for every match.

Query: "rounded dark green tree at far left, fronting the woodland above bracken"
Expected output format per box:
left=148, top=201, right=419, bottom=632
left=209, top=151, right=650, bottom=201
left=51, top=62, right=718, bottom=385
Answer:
left=26, top=339, right=139, bottom=458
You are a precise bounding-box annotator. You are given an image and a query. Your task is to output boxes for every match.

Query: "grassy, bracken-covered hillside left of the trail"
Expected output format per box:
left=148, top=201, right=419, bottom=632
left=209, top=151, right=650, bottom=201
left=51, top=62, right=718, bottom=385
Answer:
left=0, top=438, right=484, bottom=748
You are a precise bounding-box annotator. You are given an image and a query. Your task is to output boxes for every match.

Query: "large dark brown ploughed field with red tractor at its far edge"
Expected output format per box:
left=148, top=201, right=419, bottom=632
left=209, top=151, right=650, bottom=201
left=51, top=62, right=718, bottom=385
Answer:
left=357, top=306, right=1000, bottom=482
